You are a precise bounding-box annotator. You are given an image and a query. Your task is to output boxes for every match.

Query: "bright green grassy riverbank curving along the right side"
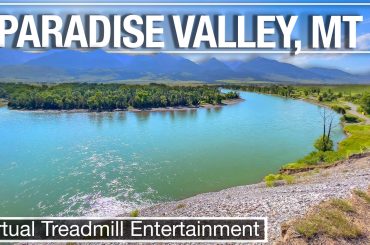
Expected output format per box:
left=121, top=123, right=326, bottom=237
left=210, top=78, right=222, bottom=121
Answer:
left=244, top=86, right=370, bottom=173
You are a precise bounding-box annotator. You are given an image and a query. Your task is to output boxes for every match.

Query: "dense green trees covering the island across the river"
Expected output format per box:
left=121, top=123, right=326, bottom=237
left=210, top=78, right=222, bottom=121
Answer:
left=0, top=83, right=239, bottom=111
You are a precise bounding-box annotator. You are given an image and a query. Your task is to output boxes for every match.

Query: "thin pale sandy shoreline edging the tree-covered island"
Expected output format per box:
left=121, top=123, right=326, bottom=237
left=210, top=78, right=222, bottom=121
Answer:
left=5, top=98, right=245, bottom=113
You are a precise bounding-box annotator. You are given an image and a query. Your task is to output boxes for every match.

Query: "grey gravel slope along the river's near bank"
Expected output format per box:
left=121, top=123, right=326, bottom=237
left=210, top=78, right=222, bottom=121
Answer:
left=140, top=154, right=370, bottom=244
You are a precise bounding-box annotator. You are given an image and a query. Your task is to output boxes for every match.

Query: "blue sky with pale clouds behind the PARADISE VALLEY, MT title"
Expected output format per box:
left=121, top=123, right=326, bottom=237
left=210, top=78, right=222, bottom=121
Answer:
left=0, top=0, right=370, bottom=73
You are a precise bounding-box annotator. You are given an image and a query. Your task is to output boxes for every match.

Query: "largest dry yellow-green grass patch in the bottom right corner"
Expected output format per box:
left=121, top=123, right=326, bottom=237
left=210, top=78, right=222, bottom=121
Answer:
left=294, top=208, right=362, bottom=239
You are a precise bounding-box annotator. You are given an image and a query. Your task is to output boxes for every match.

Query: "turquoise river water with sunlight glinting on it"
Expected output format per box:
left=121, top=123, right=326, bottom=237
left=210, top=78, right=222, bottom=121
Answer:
left=0, top=92, right=344, bottom=216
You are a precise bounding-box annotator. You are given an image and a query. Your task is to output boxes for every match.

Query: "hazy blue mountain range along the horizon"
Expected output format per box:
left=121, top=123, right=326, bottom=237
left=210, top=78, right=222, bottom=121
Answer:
left=0, top=49, right=370, bottom=84
